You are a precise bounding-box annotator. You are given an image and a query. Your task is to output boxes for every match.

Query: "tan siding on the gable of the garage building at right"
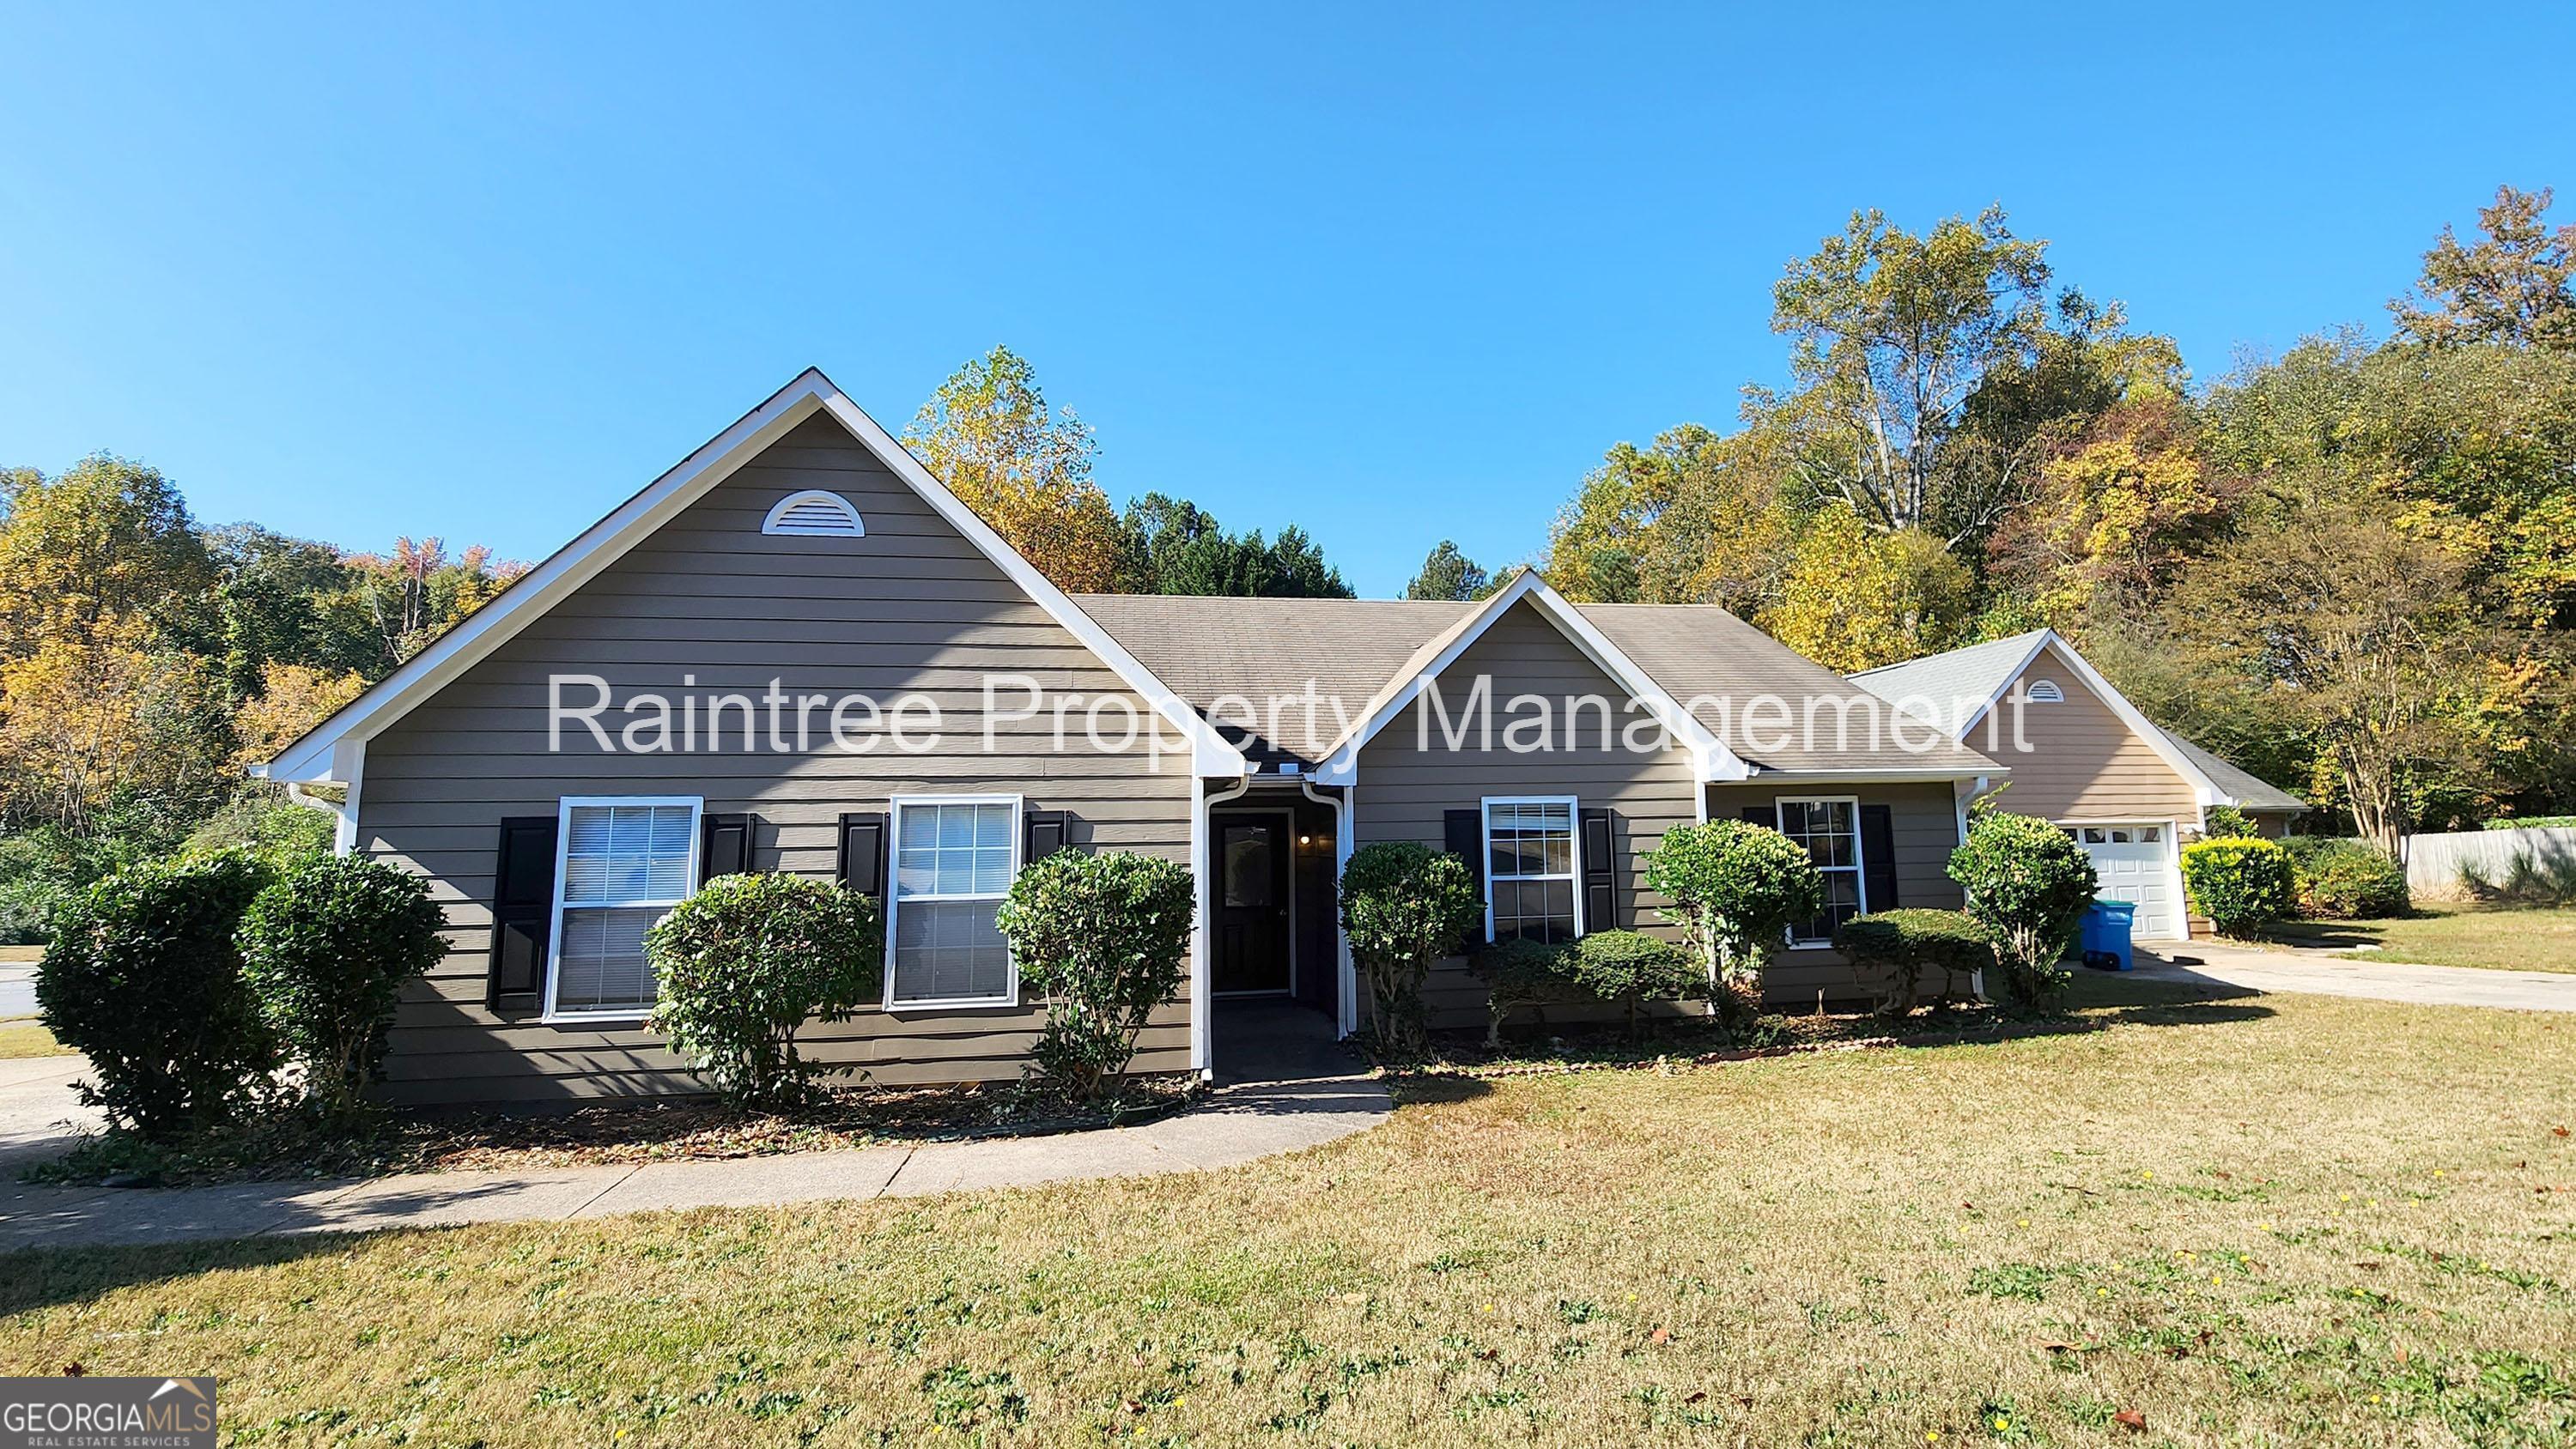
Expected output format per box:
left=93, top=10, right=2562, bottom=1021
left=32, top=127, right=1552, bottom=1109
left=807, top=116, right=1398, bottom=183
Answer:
left=1968, top=654, right=2200, bottom=826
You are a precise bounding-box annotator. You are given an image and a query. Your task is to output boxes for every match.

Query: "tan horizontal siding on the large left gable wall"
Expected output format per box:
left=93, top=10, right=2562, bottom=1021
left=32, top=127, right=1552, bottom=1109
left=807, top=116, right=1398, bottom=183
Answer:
left=358, top=417, right=1195, bottom=1101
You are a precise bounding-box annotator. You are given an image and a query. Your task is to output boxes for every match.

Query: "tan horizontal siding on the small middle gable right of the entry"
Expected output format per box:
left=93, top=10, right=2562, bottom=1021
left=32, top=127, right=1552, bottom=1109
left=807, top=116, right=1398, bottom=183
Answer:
left=1352, top=594, right=1698, bottom=1027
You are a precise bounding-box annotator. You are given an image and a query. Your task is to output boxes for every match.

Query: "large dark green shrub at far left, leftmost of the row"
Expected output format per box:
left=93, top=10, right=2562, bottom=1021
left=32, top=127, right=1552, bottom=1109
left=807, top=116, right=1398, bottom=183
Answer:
left=36, top=852, right=278, bottom=1137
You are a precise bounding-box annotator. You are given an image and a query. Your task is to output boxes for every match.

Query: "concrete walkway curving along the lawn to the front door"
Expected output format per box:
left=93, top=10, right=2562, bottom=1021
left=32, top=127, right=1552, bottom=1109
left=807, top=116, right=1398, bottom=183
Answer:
left=0, top=1009, right=1391, bottom=1251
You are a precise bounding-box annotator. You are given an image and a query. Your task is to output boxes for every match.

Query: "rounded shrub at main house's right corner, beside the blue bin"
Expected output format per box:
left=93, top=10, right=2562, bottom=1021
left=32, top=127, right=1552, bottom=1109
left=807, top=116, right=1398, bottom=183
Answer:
left=1950, top=810, right=2099, bottom=1011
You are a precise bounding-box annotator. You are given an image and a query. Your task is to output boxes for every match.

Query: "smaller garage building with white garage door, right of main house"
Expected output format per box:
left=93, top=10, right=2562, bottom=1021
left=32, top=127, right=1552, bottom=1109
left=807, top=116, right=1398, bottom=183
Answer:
left=1852, top=628, right=2308, bottom=939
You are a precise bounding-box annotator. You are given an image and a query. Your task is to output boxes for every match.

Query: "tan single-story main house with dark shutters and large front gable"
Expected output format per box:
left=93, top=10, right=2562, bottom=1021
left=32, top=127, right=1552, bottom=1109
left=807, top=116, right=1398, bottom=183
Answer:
left=265, top=371, right=2007, bottom=1101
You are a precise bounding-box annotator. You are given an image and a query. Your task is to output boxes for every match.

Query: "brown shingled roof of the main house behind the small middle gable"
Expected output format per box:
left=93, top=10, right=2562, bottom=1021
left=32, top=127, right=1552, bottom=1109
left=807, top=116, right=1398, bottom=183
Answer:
left=1082, top=577, right=2007, bottom=779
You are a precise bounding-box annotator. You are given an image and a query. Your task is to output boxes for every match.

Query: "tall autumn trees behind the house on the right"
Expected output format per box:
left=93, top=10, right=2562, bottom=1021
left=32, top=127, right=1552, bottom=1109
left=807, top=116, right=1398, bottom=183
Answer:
left=1412, top=188, right=2576, bottom=846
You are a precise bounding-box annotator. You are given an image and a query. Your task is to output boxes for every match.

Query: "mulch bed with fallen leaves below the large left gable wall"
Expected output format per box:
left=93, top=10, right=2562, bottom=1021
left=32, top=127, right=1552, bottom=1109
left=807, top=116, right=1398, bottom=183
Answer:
left=21, top=1076, right=1203, bottom=1186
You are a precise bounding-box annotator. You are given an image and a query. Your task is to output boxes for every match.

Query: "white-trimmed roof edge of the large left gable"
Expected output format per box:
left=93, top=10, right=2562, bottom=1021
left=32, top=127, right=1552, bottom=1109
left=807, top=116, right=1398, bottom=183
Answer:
left=255, top=368, right=1244, bottom=782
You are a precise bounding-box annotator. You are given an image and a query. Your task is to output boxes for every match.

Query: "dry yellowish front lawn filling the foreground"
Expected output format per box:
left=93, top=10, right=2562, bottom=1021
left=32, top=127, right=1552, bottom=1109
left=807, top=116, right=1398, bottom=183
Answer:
left=0, top=978, right=2576, bottom=1444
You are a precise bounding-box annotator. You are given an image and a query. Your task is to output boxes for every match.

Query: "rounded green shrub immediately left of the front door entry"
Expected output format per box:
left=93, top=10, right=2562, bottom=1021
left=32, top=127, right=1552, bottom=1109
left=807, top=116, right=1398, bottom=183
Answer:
left=999, top=852, right=1198, bottom=1101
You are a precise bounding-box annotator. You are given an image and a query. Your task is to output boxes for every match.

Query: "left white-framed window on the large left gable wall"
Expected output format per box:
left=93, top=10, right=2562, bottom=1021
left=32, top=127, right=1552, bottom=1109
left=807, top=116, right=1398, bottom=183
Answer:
left=546, top=795, right=701, bottom=1022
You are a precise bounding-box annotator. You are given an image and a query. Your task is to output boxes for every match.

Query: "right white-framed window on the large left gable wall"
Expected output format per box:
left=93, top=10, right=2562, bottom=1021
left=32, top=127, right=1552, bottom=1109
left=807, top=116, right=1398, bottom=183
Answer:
left=886, top=795, right=1020, bottom=1011
